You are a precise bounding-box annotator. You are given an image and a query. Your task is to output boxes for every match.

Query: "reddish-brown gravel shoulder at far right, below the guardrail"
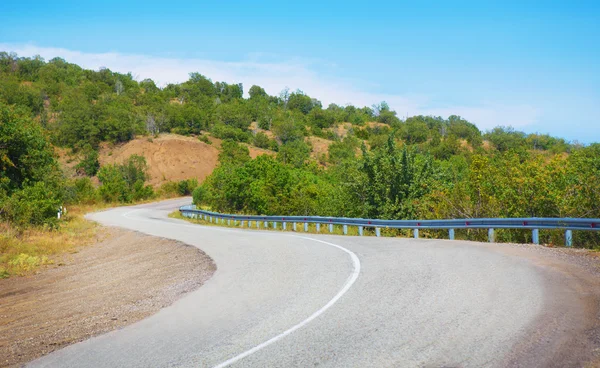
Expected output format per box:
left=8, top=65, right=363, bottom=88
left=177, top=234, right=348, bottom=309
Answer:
left=490, top=244, right=600, bottom=368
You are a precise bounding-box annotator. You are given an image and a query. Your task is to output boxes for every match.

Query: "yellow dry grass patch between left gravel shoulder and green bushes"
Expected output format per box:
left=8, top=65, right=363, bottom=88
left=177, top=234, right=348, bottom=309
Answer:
left=0, top=204, right=109, bottom=278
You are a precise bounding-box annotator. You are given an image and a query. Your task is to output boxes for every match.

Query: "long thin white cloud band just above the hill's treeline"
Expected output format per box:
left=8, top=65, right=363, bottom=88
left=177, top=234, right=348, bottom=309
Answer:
left=0, top=43, right=541, bottom=129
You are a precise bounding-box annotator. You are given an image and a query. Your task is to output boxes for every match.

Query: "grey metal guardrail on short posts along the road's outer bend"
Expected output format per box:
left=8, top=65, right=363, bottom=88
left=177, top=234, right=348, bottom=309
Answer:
left=179, top=205, right=600, bottom=247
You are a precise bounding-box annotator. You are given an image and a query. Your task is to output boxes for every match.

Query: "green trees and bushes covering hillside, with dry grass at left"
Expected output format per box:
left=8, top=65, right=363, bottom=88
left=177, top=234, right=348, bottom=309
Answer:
left=0, top=52, right=600, bottom=270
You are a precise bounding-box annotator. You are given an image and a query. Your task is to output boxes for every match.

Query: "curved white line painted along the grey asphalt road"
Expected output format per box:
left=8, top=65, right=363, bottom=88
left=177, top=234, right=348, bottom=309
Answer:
left=123, top=208, right=360, bottom=368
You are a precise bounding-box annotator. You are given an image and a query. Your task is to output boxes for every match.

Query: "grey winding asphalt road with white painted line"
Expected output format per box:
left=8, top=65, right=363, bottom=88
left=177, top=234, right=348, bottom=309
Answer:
left=30, top=199, right=598, bottom=367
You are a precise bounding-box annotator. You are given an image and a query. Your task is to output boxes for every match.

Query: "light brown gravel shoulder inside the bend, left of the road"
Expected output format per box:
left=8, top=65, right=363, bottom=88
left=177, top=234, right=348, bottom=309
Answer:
left=0, top=228, right=216, bottom=367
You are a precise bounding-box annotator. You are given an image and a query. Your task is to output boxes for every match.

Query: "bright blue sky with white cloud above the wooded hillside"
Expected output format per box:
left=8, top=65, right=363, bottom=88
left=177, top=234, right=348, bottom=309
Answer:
left=0, top=1, right=600, bottom=143
